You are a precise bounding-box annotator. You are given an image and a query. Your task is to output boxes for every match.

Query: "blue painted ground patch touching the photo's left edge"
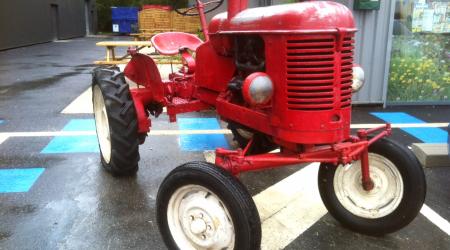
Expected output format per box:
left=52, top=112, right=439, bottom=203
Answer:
left=0, top=168, right=45, bottom=193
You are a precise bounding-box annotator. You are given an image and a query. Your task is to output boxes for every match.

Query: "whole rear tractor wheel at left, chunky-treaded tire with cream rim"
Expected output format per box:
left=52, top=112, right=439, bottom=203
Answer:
left=92, top=68, right=140, bottom=175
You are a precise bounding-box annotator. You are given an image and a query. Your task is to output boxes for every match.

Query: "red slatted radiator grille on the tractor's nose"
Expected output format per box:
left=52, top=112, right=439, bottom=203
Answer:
left=286, top=35, right=353, bottom=110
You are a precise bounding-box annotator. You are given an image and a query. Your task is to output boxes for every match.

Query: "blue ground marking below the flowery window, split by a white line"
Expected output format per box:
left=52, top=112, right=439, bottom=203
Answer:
left=371, top=112, right=448, bottom=143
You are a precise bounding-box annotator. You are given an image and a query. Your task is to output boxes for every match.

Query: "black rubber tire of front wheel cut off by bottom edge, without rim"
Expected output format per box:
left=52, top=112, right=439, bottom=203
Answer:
left=156, top=162, right=261, bottom=250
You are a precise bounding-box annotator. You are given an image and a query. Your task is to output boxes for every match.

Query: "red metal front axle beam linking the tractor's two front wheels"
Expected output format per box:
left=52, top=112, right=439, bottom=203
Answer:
left=215, top=124, right=392, bottom=190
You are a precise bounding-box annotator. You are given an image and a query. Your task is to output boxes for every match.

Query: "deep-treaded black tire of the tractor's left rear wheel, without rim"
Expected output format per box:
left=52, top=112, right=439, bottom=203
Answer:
left=92, top=67, right=140, bottom=176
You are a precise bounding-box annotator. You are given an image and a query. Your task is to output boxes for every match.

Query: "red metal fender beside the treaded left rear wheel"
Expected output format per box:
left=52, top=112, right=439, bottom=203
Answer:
left=124, top=53, right=164, bottom=103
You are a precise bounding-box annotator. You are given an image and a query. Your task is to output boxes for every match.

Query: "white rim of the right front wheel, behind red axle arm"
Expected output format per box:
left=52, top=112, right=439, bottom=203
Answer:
left=333, top=153, right=403, bottom=219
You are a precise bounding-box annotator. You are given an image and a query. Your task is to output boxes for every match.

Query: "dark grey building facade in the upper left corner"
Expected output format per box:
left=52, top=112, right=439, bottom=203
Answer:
left=0, top=0, right=97, bottom=50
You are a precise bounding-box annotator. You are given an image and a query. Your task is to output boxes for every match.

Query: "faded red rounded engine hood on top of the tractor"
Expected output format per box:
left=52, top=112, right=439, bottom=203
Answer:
left=209, top=1, right=355, bottom=34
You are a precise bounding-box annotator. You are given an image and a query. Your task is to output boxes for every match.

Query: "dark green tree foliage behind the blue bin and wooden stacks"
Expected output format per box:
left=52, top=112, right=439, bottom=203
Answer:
left=96, top=0, right=188, bottom=32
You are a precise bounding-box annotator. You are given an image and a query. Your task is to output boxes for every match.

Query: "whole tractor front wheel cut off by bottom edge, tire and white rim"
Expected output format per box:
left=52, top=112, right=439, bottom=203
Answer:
left=156, top=162, right=261, bottom=250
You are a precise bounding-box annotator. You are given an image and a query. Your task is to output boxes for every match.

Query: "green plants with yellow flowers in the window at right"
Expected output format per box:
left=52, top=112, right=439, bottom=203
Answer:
left=388, top=34, right=450, bottom=101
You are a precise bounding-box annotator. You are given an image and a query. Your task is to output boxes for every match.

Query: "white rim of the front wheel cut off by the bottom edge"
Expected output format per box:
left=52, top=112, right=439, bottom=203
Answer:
left=167, top=185, right=235, bottom=249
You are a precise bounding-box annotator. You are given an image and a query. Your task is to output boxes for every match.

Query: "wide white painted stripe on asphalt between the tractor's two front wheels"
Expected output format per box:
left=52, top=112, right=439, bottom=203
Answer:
left=253, top=163, right=327, bottom=249
